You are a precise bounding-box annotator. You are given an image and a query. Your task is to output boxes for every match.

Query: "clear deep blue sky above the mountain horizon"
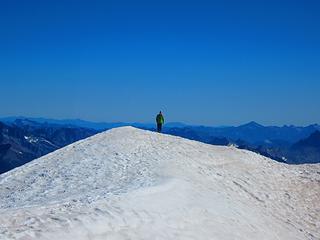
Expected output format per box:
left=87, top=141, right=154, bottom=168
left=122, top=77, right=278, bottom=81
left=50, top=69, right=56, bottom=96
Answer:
left=0, top=0, right=320, bottom=125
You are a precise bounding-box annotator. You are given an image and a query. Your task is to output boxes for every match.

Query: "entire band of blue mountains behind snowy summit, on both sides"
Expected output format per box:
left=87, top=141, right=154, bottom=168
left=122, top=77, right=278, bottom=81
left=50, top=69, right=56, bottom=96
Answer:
left=0, top=117, right=320, bottom=173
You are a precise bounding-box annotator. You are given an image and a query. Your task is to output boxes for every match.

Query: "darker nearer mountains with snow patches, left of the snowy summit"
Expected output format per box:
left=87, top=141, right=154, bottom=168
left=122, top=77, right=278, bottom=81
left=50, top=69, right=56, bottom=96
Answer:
left=0, top=119, right=98, bottom=174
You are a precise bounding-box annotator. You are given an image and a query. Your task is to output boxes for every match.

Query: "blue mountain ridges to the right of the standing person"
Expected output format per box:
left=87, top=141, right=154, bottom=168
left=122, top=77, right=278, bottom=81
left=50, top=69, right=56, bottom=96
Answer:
left=165, top=122, right=320, bottom=164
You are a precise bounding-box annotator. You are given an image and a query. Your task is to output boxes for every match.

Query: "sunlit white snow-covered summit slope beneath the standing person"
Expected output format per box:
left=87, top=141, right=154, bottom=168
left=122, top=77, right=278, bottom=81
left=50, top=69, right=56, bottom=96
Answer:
left=0, top=127, right=320, bottom=240
